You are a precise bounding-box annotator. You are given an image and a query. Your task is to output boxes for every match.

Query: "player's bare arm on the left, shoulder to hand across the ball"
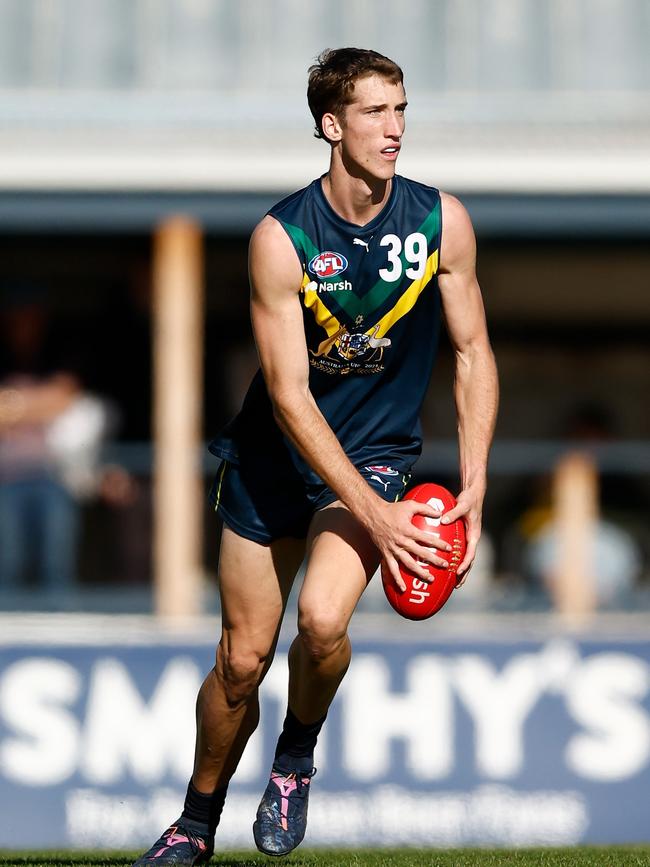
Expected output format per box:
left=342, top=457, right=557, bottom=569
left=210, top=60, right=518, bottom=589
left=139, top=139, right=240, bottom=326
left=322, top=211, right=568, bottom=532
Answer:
left=249, top=216, right=449, bottom=589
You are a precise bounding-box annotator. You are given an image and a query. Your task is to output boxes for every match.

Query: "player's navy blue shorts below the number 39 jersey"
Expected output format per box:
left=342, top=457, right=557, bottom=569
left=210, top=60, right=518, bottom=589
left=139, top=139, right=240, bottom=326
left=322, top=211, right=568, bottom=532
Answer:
left=210, top=460, right=411, bottom=545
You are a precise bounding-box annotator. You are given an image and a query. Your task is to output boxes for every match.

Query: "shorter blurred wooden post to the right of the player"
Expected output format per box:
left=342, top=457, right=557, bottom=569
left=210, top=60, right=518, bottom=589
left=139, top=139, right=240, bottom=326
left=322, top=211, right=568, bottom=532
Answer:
left=550, top=452, right=598, bottom=625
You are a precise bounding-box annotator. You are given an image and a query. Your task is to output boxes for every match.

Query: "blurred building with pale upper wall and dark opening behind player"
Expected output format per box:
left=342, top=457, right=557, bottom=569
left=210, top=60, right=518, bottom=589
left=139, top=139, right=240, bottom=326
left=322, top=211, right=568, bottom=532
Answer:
left=0, top=0, right=650, bottom=611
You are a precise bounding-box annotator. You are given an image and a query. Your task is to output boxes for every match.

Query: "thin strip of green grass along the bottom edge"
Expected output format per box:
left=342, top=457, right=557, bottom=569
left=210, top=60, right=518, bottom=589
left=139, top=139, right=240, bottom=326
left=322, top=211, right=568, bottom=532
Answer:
left=0, top=846, right=650, bottom=867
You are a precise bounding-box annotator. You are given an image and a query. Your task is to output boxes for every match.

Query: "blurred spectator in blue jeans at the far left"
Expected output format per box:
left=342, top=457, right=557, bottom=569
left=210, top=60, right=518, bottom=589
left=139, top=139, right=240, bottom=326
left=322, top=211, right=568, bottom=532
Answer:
left=0, top=285, right=108, bottom=593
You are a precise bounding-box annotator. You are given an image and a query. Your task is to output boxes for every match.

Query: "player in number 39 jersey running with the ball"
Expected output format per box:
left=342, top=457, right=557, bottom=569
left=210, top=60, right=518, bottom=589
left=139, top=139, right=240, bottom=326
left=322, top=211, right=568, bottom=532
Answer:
left=136, top=48, right=497, bottom=867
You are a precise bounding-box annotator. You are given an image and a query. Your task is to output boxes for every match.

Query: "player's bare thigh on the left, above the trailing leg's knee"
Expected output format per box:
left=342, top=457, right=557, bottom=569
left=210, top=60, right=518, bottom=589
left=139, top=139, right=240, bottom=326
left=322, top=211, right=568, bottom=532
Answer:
left=219, top=526, right=305, bottom=657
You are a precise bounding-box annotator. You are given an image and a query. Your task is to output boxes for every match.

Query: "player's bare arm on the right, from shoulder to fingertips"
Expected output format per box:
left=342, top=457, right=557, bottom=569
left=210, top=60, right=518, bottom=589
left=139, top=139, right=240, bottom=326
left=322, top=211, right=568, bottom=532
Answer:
left=438, top=193, right=499, bottom=585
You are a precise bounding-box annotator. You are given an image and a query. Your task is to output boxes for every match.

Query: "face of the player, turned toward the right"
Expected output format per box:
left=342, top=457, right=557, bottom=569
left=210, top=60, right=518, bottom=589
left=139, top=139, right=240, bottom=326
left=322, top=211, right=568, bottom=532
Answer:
left=340, top=75, right=406, bottom=180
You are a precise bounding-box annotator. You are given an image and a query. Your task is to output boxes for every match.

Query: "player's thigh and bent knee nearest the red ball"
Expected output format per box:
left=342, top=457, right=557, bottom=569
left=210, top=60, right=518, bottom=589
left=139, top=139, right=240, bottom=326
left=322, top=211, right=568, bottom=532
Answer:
left=298, top=501, right=379, bottom=638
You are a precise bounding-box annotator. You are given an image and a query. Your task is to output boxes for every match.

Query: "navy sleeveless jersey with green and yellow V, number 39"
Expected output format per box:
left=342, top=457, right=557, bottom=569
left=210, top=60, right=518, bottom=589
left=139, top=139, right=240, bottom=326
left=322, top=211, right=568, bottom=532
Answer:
left=210, top=176, right=441, bottom=483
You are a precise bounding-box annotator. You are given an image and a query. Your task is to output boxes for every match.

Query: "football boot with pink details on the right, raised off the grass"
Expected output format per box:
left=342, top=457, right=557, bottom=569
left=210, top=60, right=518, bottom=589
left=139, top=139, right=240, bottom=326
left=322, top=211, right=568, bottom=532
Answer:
left=253, top=765, right=316, bottom=855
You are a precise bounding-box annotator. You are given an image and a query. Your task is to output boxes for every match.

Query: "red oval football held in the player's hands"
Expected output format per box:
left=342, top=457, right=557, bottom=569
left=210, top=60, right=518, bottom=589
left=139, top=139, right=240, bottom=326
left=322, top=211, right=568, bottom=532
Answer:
left=381, top=482, right=466, bottom=620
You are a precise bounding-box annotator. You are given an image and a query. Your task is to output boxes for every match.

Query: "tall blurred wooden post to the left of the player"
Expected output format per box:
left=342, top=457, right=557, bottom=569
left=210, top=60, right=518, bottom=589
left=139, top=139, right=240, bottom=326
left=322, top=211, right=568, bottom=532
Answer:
left=153, top=217, right=204, bottom=617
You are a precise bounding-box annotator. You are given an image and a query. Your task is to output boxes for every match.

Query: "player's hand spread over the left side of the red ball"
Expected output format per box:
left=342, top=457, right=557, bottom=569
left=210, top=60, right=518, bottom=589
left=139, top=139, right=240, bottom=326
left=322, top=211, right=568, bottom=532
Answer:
left=363, top=497, right=451, bottom=590
